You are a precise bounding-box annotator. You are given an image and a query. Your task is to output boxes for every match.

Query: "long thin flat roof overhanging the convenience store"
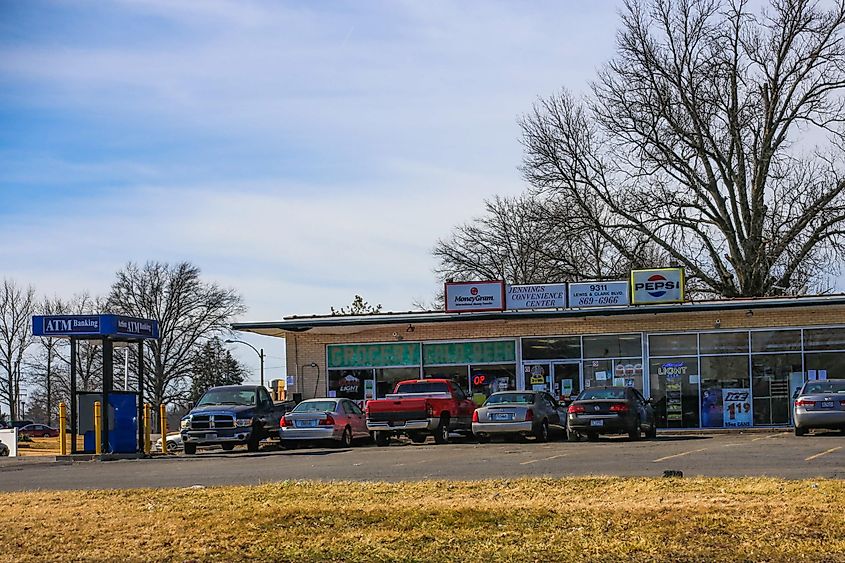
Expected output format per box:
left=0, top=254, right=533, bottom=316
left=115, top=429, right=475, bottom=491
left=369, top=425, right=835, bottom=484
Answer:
left=231, top=293, right=845, bottom=336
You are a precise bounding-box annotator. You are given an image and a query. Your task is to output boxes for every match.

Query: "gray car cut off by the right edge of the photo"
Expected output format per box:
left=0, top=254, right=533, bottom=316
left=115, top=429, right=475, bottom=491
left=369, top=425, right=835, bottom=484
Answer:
left=792, top=379, right=845, bottom=436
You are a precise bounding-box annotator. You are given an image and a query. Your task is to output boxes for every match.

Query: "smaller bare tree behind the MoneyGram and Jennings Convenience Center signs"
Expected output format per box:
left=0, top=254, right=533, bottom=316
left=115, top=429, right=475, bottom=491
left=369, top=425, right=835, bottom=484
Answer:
left=432, top=193, right=659, bottom=284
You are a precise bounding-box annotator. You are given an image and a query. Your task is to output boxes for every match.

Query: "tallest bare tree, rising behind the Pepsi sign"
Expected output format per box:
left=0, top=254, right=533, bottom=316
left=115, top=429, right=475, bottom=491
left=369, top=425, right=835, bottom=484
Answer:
left=521, top=0, right=845, bottom=297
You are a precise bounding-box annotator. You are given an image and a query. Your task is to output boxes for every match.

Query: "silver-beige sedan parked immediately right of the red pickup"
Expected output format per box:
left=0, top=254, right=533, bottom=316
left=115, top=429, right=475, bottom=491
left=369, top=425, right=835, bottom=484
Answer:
left=472, top=391, right=566, bottom=442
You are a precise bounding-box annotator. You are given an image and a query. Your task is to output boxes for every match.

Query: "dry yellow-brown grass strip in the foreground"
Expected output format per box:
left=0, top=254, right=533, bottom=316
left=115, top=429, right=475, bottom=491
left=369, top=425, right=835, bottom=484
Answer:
left=0, top=477, right=845, bottom=562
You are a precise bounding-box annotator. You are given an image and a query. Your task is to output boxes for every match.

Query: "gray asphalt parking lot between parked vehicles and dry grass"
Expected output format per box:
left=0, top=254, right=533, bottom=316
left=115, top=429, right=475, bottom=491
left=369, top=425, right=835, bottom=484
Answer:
left=0, top=432, right=845, bottom=491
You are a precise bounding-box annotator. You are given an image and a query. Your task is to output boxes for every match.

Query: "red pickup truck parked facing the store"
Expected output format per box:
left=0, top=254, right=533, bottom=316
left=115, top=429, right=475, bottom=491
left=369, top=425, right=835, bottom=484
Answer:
left=366, top=379, right=476, bottom=446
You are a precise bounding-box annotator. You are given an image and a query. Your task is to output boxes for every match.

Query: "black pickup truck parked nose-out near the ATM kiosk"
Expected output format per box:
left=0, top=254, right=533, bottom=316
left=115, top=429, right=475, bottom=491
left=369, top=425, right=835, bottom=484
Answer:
left=180, top=385, right=293, bottom=455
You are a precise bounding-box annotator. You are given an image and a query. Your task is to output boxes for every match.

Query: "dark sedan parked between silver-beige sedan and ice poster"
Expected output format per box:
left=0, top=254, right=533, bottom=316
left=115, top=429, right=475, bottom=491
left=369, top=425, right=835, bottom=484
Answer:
left=567, top=387, right=657, bottom=442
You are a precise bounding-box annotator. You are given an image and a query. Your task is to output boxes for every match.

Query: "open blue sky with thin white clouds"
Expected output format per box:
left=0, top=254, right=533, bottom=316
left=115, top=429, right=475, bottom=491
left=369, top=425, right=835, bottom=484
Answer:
left=0, top=0, right=618, bottom=384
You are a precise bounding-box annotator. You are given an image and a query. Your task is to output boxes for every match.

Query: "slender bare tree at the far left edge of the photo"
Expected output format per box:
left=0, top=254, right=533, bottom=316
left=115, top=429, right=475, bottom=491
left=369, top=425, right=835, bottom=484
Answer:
left=0, top=278, right=36, bottom=420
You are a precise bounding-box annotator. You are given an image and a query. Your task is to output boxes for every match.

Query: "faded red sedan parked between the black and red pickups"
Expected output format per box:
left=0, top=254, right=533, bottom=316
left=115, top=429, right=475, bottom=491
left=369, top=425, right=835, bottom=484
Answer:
left=279, top=398, right=370, bottom=448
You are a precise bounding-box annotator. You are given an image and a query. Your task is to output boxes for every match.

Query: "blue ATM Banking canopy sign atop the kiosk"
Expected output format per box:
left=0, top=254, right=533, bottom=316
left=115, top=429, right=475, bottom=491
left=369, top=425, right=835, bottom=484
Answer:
left=32, top=315, right=159, bottom=341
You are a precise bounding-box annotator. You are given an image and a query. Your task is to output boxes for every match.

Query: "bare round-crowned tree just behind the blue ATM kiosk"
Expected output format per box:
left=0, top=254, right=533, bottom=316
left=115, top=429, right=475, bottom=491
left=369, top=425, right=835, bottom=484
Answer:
left=108, top=262, right=246, bottom=404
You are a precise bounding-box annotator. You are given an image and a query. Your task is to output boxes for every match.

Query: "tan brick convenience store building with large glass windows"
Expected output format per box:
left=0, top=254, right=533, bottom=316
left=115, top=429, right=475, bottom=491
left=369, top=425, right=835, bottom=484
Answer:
left=232, top=278, right=845, bottom=428
